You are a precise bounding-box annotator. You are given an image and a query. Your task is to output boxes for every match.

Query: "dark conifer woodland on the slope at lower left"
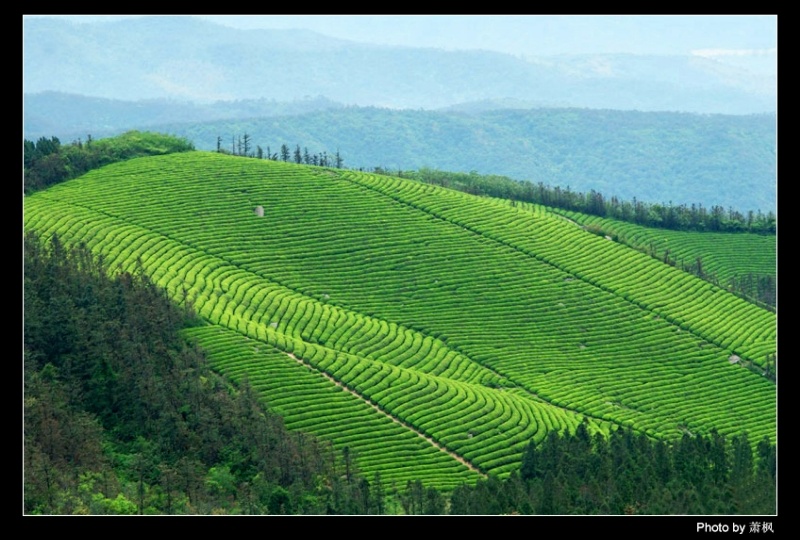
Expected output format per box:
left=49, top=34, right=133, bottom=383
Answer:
left=23, top=234, right=372, bottom=514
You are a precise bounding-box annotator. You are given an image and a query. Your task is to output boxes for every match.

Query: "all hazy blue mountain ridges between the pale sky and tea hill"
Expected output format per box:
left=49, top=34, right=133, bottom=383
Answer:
left=23, top=17, right=777, bottom=212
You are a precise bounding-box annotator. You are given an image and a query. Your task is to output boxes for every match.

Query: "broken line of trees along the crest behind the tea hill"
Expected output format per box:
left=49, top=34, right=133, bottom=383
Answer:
left=23, top=131, right=777, bottom=234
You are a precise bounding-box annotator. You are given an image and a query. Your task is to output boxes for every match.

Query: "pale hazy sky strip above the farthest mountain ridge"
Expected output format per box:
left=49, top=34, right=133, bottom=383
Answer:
left=26, top=15, right=778, bottom=56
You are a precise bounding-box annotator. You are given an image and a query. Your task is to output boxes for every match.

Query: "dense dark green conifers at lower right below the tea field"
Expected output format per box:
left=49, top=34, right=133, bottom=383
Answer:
left=448, top=424, right=776, bottom=515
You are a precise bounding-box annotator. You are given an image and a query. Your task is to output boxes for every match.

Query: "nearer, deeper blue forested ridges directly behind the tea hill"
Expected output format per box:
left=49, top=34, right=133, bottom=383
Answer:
left=25, top=93, right=777, bottom=212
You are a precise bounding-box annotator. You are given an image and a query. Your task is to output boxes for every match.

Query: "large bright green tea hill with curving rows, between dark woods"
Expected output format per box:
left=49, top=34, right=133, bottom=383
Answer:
left=24, top=152, right=776, bottom=489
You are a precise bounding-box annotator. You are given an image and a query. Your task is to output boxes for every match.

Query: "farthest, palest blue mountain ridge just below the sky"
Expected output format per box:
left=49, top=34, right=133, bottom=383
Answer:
left=23, top=17, right=777, bottom=114
